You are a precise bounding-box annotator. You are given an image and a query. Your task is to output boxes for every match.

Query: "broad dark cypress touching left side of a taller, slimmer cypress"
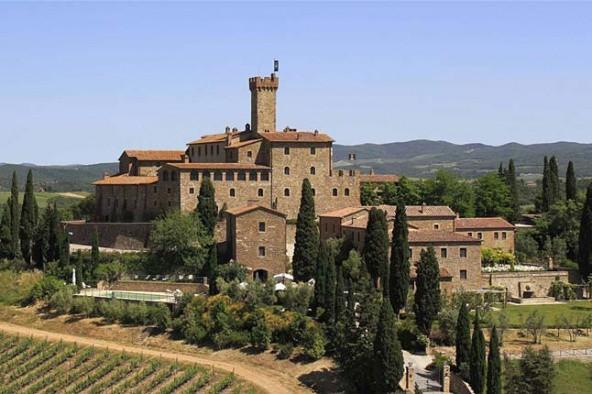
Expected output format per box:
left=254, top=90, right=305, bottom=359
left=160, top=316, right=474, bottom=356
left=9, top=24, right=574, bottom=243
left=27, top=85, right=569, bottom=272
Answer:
left=362, top=207, right=389, bottom=288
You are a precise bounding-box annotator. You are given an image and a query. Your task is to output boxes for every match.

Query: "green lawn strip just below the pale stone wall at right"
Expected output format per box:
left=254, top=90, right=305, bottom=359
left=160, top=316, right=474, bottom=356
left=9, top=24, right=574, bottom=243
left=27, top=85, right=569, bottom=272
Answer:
left=493, top=300, right=592, bottom=327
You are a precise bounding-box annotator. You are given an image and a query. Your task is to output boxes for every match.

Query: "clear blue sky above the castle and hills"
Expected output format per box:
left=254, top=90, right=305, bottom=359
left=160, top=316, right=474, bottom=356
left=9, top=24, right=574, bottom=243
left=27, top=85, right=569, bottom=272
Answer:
left=0, top=2, right=592, bottom=164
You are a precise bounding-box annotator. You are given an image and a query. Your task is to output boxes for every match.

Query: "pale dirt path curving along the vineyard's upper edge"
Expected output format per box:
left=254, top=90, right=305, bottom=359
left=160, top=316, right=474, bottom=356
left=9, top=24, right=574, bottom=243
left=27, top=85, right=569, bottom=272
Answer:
left=0, top=322, right=310, bottom=394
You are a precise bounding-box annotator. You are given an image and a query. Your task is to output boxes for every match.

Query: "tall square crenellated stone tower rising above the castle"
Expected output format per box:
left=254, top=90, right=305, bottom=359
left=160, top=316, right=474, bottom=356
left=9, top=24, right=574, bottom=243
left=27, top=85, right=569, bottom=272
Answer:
left=249, top=74, right=280, bottom=133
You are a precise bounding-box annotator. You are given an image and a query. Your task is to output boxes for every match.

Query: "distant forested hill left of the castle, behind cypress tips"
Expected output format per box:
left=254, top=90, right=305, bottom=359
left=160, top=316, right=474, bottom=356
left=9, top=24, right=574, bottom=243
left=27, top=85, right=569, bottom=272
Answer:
left=0, top=163, right=119, bottom=192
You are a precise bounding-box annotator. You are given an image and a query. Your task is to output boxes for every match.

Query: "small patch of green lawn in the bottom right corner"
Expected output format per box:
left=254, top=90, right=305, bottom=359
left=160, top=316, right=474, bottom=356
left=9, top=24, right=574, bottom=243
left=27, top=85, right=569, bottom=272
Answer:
left=554, top=360, right=592, bottom=394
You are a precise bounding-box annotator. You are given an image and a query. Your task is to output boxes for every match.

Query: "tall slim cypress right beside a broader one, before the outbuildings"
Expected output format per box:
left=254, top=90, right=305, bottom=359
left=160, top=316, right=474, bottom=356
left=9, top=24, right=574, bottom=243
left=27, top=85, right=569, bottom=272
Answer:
left=389, top=202, right=410, bottom=315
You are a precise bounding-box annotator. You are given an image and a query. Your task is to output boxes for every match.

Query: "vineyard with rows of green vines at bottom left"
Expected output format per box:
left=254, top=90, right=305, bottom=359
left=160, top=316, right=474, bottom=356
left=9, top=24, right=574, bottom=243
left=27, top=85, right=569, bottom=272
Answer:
left=0, top=332, right=254, bottom=394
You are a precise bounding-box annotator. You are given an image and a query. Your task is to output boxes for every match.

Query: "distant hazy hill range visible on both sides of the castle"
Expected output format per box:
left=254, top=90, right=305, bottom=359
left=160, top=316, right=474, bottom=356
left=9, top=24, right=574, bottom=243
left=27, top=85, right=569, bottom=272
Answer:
left=0, top=140, right=592, bottom=192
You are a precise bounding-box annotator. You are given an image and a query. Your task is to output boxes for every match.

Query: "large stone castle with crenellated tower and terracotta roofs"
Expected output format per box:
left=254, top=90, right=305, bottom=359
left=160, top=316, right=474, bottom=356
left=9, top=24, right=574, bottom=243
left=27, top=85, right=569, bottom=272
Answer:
left=94, top=74, right=392, bottom=222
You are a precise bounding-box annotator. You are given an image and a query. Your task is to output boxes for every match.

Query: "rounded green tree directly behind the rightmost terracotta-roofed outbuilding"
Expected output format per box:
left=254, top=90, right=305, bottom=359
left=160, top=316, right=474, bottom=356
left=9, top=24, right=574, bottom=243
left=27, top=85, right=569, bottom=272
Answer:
left=475, top=173, right=511, bottom=217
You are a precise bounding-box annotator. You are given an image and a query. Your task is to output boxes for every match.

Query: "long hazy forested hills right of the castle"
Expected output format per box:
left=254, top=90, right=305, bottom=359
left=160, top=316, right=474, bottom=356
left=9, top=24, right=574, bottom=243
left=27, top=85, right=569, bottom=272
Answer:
left=334, top=140, right=592, bottom=177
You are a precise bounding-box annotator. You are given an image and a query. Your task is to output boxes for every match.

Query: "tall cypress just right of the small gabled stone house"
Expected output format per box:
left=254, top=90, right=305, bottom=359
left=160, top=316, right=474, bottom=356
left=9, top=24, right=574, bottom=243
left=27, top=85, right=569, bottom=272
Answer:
left=292, top=178, right=319, bottom=282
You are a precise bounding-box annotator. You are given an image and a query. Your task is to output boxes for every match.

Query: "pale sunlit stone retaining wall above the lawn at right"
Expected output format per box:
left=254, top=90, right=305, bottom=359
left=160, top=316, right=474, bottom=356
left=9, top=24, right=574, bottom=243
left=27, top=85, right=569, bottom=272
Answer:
left=482, top=271, right=569, bottom=297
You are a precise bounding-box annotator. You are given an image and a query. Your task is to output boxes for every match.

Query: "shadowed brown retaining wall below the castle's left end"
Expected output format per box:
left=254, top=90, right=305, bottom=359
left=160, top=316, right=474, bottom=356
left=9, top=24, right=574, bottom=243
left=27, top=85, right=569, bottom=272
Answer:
left=64, top=221, right=152, bottom=250
